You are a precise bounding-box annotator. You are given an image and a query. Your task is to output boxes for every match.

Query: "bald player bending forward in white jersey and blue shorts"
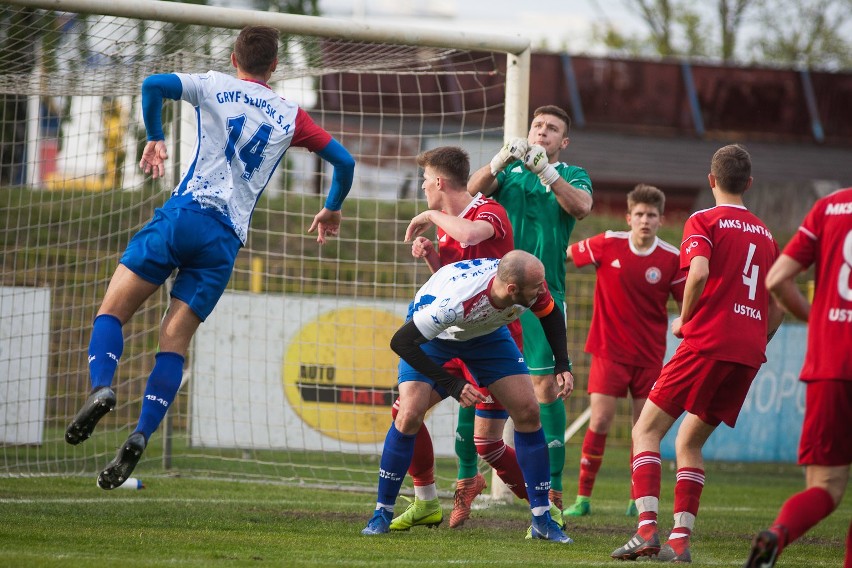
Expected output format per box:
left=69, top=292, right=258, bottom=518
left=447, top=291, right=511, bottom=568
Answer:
left=361, top=250, right=574, bottom=543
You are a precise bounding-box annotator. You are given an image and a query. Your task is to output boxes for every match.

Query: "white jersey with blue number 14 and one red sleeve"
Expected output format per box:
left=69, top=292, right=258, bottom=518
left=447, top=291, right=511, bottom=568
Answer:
left=166, top=71, right=331, bottom=244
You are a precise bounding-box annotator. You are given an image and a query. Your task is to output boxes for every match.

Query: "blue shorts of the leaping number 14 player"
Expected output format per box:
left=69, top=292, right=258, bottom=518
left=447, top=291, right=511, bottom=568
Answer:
left=119, top=208, right=242, bottom=321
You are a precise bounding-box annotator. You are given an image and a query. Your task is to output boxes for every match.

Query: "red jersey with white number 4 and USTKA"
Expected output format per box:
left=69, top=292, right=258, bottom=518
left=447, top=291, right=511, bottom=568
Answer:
left=680, top=205, right=779, bottom=368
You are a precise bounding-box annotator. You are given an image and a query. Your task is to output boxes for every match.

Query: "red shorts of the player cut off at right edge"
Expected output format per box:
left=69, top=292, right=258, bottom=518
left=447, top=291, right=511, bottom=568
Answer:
left=799, top=380, right=852, bottom=467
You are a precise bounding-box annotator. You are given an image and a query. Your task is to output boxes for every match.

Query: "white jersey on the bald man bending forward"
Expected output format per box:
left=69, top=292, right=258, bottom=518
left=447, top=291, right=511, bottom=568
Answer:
left=409, top=258, right=553, bottom=341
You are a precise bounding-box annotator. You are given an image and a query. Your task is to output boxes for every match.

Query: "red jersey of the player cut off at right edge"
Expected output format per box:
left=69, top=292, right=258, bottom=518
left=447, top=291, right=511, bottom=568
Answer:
left=784, top=188, right=852, bottom=381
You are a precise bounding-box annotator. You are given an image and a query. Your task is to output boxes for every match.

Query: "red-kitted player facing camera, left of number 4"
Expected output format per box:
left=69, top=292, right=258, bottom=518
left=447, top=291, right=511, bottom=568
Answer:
left=564, top=184, right=686, bottom=517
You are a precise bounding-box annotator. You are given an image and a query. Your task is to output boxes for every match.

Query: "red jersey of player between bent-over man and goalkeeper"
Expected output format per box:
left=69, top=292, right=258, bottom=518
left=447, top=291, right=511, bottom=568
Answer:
left=437, top=193, right=523, bottom=342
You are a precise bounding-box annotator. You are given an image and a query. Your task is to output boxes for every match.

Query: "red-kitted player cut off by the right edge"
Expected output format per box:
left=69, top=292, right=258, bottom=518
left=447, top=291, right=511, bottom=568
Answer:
left=746, top=188, right=852, bottom=568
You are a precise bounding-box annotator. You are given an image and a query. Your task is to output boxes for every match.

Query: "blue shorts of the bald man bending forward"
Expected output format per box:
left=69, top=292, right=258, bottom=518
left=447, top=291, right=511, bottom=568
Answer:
left=399, top=326, right=529, bottom=398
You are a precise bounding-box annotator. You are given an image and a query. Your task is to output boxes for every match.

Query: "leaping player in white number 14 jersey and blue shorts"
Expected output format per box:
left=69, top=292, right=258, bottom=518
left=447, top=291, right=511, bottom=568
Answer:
left=65, top=26, right=355, bottom=489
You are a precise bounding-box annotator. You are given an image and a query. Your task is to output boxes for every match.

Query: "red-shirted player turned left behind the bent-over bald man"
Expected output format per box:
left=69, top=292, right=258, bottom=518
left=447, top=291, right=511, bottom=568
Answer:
left=390, top=146, right=561, bottom=530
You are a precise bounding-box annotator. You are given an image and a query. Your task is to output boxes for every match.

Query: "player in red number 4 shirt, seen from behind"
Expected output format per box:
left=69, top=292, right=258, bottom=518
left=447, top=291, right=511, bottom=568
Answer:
left=611, top=144, right=783, bottom=562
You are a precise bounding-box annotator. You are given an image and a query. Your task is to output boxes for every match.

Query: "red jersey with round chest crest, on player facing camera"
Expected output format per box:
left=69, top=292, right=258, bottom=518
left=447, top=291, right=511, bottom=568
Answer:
left=571, top=231, right=686, bottom=367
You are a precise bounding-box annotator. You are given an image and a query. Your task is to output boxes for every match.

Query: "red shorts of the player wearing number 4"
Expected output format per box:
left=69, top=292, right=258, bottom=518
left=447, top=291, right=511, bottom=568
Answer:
left=648, top=343, right=758, bottom=428
